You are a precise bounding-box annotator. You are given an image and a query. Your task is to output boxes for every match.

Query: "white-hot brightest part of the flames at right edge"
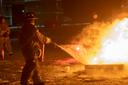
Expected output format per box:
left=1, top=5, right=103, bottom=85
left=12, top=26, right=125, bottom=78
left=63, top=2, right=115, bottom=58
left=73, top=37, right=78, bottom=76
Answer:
left=90, top=18, right=128, bottom=64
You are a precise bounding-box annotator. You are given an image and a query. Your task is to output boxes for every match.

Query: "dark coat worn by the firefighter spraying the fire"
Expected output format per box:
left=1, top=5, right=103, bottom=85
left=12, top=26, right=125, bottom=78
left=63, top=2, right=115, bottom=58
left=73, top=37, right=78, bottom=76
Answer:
left=19, top=23, right=48, bottom=61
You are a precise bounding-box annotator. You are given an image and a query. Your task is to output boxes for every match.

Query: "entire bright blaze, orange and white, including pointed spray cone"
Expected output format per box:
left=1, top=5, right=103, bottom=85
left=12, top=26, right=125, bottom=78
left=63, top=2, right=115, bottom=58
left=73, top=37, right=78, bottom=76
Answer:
left=59, top=18, right=128, bottom=65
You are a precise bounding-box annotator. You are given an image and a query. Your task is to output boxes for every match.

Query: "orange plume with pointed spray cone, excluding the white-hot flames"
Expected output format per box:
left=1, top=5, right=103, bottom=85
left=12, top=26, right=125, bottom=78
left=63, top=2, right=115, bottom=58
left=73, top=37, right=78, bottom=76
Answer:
left=59, top=23, right=110, bottom=64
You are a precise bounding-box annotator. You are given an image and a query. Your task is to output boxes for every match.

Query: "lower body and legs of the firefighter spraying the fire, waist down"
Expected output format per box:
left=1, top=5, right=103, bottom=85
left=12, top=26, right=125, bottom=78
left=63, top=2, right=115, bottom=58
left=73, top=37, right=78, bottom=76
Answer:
left=21, top=44, right=44, bottom=85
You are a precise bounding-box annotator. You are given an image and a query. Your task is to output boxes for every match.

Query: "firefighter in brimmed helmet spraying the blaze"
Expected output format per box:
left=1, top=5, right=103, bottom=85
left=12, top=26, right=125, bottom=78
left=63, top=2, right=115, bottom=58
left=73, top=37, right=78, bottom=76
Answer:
left=19, top=12, right=51, bottom=85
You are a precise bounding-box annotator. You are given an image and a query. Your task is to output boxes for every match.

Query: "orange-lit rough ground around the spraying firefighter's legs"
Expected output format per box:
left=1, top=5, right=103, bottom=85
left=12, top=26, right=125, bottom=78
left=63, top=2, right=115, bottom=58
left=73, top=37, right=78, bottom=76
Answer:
left=0, top=40, right=128, bottom=85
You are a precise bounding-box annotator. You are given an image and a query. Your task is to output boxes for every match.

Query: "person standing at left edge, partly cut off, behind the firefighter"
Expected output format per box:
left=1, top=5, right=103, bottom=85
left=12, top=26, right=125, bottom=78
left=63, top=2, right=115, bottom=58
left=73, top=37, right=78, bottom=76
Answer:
left=0, top=16, right=13, bottom=59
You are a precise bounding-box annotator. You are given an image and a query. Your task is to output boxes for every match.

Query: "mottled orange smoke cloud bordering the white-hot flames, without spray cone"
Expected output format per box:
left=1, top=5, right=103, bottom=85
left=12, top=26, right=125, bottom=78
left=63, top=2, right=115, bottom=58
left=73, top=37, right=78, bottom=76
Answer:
left=72, top=22, right=111, bottom=63
